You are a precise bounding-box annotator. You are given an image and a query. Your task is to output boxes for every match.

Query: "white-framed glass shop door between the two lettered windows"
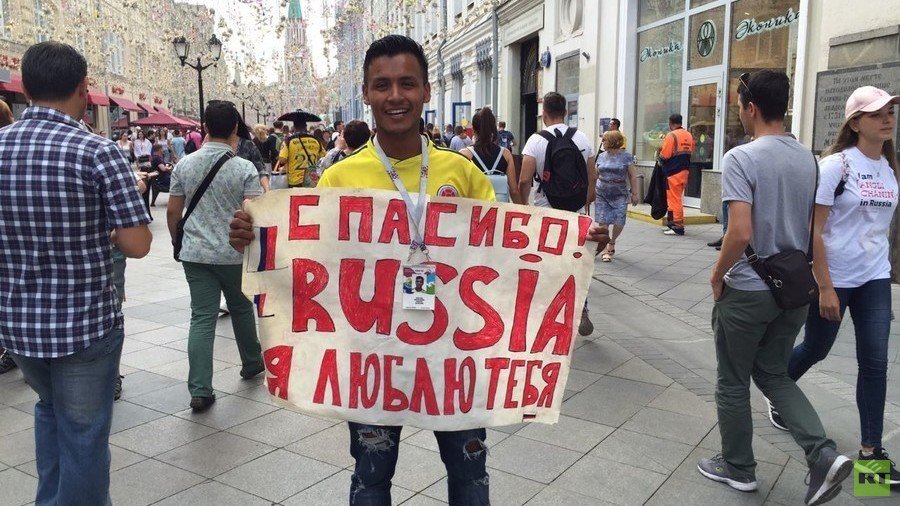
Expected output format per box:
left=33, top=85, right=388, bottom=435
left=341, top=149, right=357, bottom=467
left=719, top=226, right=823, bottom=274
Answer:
left=682, top=77, right=722, bottom=207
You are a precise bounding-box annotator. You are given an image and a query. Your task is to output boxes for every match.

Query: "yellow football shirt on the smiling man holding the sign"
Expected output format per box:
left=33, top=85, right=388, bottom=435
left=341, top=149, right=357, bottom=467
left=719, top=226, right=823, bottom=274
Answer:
left=318, top=140, right=496, bottom=201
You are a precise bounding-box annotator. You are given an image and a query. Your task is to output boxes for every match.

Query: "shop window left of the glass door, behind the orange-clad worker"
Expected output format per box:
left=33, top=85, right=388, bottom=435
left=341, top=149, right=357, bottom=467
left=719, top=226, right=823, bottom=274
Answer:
left=623, top=20, right=684, bottom=160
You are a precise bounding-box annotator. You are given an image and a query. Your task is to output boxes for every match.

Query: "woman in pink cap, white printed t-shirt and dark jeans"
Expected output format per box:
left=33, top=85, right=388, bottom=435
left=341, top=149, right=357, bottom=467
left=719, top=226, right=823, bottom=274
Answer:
left=770, top=86, right=900, bottom=478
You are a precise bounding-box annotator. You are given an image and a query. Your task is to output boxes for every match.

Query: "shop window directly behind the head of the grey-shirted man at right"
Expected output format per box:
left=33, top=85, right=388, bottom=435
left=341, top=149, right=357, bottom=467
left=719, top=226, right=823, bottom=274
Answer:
left=724, top=0, right=801, bottom=152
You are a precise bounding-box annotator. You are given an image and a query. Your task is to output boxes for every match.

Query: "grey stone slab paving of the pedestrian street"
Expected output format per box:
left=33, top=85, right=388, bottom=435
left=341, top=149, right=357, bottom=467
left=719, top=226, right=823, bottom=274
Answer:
left=0, top=198, right=900, bottom=506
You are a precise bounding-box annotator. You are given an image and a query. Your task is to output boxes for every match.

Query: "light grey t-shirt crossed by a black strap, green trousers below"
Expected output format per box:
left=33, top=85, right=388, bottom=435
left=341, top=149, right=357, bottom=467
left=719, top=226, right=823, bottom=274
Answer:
left=170, top=142, right=262, bottom=265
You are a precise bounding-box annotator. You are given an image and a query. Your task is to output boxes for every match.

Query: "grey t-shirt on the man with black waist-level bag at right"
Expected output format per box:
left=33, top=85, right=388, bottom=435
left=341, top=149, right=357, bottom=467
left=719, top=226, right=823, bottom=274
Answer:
left=722, top=134, right=816, bottom=291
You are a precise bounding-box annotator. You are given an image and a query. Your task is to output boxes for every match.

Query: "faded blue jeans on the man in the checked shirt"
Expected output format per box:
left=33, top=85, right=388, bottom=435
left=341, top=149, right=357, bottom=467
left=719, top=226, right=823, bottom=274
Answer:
left=11, top=328, right=124, bottom=506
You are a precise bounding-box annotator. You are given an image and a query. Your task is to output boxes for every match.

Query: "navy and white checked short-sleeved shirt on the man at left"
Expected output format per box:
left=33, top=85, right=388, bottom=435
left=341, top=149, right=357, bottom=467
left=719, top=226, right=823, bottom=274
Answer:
left=0, top=107, right=150, bottom=358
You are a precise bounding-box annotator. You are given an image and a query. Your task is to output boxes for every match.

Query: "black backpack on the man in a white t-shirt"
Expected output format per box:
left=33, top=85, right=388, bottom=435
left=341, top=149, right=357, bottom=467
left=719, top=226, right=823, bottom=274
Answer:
left=538, top=128, right=588, bottom=211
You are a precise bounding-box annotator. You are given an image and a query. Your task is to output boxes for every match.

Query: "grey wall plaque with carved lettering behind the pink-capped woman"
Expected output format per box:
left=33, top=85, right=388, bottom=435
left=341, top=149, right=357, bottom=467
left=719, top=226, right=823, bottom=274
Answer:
left=813, top=62, right=900, bottom=153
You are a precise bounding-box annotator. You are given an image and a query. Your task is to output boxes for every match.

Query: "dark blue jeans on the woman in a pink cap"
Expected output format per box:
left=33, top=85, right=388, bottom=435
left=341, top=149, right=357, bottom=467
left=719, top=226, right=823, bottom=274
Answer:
left=788, top=279, right=891, bottom=447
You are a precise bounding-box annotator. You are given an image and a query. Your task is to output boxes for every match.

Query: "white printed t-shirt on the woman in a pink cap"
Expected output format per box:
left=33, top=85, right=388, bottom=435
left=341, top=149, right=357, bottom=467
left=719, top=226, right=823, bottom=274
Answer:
left=816, top=147, right=898, bottom=288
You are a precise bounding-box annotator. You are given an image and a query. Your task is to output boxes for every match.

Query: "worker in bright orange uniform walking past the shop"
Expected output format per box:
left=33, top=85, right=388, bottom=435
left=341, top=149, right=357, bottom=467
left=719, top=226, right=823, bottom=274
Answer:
left=659, top=114, right=694, bottom=235
